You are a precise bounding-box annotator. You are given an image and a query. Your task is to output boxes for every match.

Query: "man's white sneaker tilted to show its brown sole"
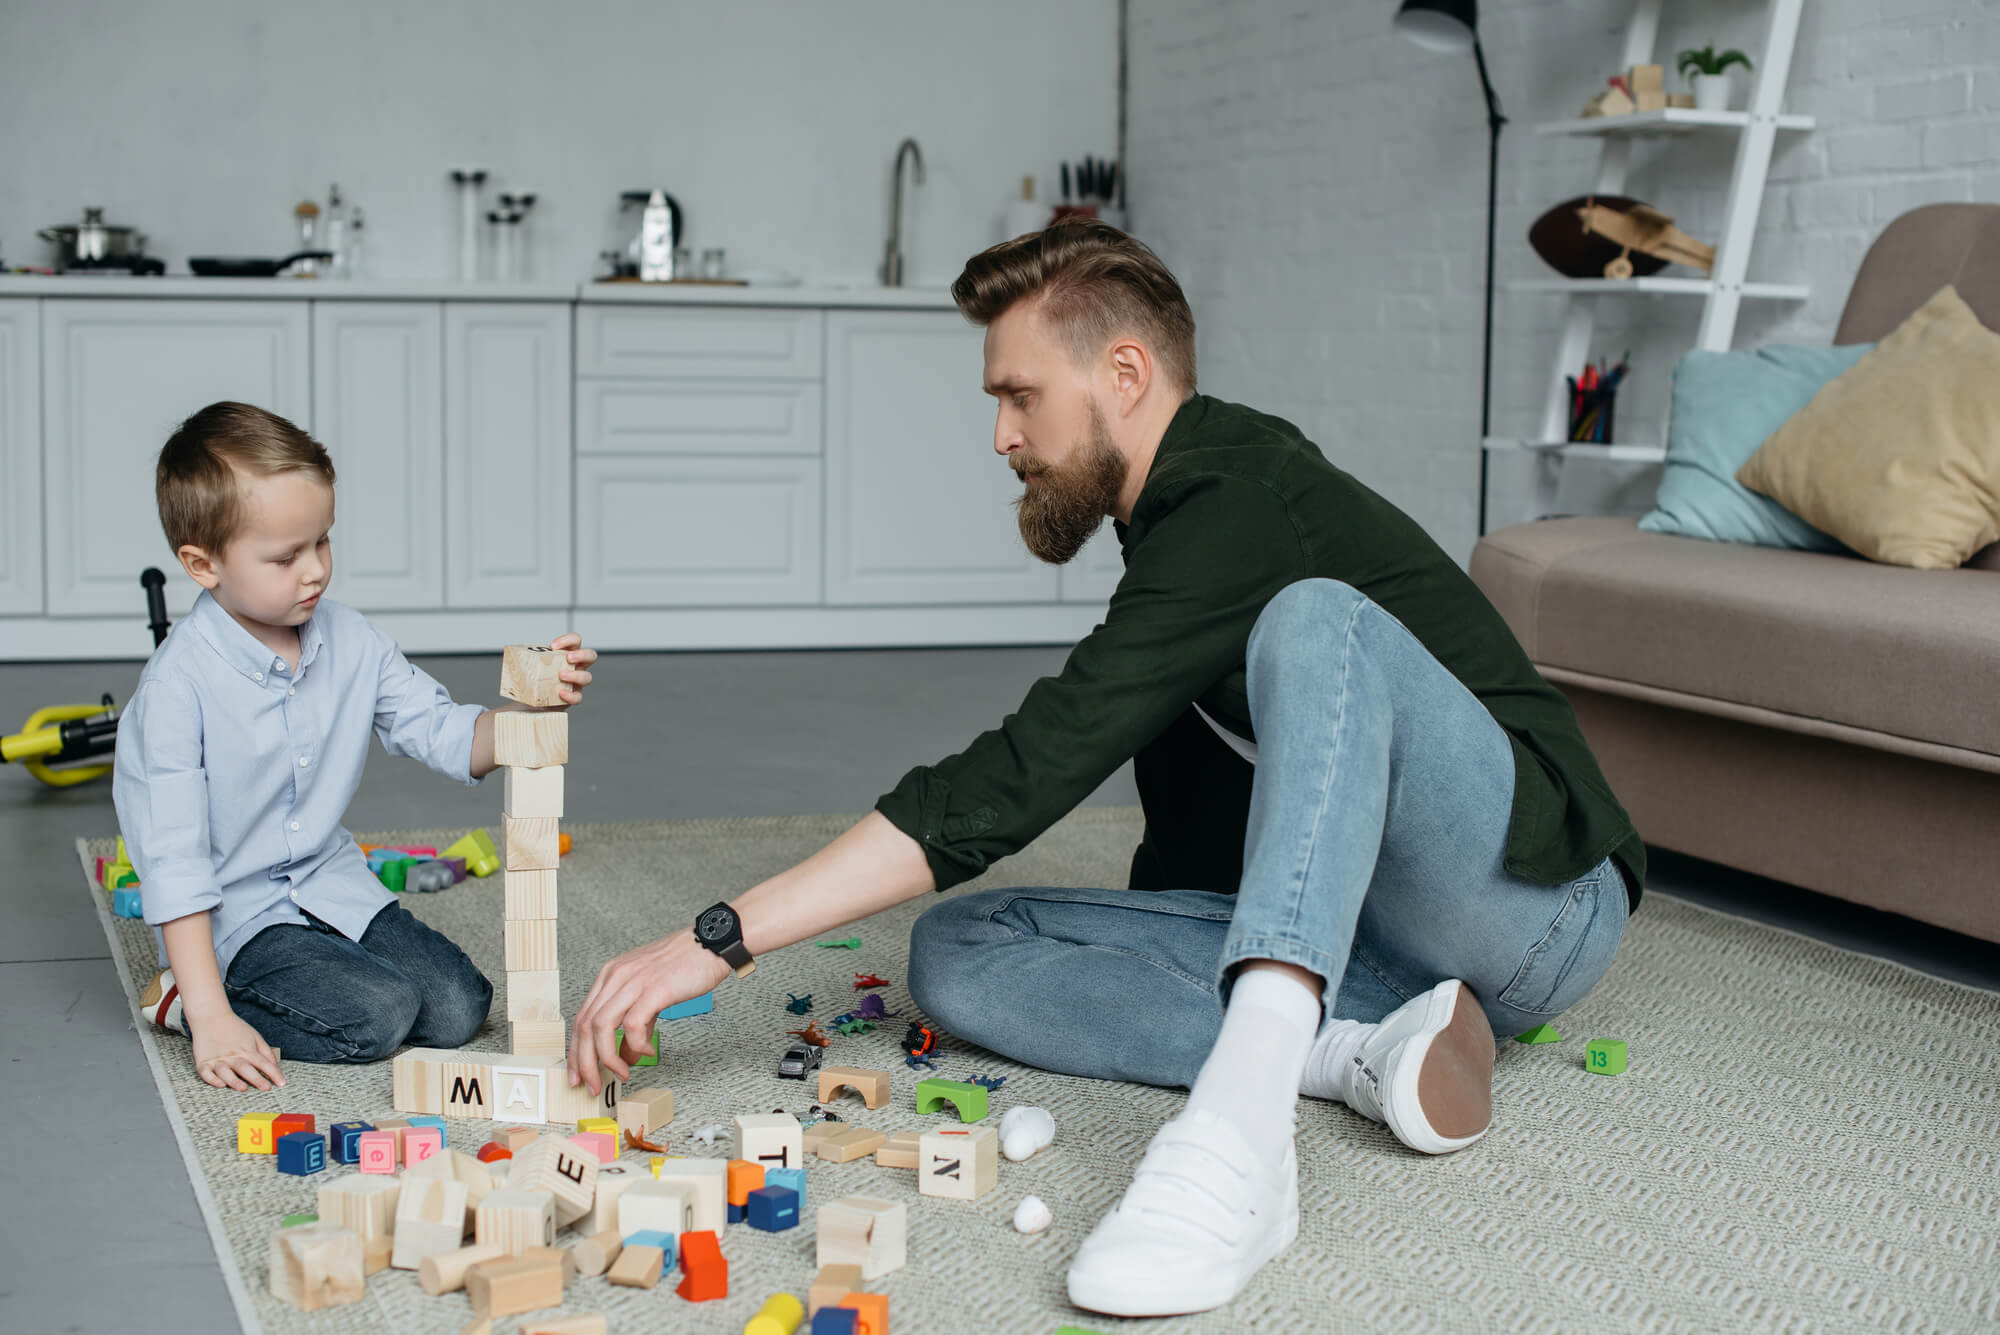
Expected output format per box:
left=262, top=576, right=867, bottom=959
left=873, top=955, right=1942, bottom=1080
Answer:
left=1340, top=977, right=1494, bottom=1155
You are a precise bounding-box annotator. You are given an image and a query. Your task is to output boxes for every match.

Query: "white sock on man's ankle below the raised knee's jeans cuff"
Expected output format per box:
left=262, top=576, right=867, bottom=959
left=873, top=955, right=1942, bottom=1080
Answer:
left=1188, top=969, right=1320, bottom=1161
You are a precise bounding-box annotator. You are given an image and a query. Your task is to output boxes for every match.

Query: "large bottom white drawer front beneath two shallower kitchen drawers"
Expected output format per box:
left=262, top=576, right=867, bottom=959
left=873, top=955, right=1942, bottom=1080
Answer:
left=576, top=454, right=820, bottom=608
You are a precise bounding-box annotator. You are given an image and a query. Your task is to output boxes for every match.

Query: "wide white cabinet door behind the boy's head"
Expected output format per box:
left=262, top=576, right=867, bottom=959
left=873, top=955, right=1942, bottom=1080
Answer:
left=42, top=299, right=312, bottom=619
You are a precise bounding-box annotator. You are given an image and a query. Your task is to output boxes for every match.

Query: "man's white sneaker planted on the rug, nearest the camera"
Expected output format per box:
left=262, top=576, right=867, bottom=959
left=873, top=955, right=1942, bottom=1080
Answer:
left=1070, top=1111, right=1298, bottom=1317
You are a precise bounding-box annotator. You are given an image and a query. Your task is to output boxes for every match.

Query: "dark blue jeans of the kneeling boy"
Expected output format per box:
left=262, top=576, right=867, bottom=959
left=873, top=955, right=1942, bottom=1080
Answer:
left=182, top=903, right=494, bottom=1063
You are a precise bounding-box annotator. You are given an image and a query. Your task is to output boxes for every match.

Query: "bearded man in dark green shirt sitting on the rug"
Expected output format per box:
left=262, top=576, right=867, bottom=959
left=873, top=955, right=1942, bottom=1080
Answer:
left=570, top=222, right=1644, bottom=1315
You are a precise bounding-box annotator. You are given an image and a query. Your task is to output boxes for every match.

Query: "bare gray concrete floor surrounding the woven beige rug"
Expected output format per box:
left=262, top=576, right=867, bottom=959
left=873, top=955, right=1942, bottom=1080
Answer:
left=0, top=650, right=2000, bottom=1331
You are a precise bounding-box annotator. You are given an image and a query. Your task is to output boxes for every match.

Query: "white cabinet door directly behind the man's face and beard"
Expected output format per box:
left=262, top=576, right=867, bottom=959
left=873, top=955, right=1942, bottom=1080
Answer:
left=826, top=312, right=1060, bottom=606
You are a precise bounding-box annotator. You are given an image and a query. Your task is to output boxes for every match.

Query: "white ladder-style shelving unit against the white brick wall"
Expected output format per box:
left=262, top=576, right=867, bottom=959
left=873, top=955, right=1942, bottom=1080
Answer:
left=1480, top=0, right=1814, bottom=479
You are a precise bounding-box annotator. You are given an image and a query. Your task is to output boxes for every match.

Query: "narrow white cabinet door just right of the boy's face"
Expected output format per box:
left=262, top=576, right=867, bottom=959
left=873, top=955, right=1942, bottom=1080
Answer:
left=312, top=302, right=444, bottom=612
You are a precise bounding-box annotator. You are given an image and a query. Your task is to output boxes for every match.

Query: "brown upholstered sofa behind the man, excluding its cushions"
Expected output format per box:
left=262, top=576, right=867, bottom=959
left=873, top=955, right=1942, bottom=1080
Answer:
left=1472, top=204, right=2000, bottom=941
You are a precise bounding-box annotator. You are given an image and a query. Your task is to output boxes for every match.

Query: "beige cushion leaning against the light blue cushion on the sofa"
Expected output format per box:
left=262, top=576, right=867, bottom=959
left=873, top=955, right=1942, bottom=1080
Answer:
left=1736, top=288, right=2000, bottom=570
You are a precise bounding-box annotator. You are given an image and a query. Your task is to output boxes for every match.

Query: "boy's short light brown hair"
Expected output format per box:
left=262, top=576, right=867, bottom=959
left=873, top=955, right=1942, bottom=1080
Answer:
left=154, top=402, right=334, bottom=556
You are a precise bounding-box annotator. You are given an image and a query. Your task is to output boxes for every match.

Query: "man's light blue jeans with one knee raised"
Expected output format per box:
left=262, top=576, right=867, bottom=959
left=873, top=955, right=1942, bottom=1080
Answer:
left=910, top=580, right=1628, bottom=1085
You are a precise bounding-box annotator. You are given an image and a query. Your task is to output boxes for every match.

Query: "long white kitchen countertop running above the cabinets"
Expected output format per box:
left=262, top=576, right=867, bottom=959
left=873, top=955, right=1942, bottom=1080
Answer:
left=0, top=274, right=952, bottom=310
